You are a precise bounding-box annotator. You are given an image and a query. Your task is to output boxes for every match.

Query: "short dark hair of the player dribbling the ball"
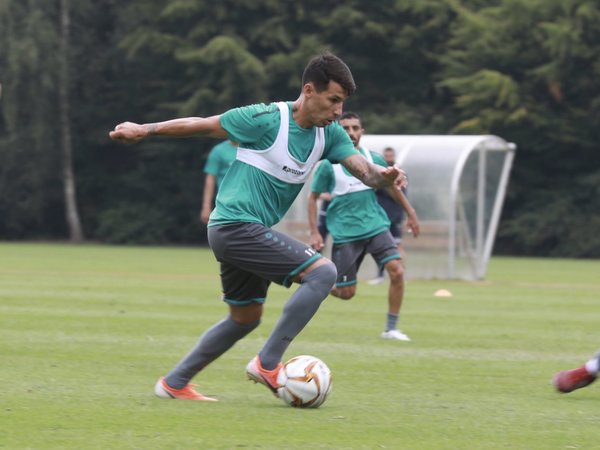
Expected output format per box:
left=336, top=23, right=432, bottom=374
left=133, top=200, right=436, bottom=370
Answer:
left=302, top=52, right=356, bottom=95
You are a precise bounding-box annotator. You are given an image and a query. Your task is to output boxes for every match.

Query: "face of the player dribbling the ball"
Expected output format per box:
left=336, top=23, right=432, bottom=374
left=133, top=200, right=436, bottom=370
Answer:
left=305, top=81, right=348, bottom=127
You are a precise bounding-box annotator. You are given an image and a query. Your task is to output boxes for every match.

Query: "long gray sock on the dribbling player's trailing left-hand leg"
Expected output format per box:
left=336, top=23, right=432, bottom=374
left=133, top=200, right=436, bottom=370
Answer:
left=165, top=316, right=260, bottom=389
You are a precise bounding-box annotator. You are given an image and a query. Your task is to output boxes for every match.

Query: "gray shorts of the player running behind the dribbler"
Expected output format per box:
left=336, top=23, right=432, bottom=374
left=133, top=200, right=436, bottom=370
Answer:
left=331, top=230, right=401, bottom=287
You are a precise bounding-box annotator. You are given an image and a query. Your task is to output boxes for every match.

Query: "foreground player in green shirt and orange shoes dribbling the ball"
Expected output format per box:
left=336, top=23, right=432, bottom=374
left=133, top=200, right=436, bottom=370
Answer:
left=110, top=53, right=400, bottom=401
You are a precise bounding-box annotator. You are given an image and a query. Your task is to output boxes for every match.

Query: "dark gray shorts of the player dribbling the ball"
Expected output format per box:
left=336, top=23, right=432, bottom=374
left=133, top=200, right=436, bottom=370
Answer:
left=208, top=222, right=321, bottom=306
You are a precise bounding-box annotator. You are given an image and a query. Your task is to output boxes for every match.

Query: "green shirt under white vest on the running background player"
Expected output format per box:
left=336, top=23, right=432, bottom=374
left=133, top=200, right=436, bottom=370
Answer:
left=311, top=148, right=390, bottom=244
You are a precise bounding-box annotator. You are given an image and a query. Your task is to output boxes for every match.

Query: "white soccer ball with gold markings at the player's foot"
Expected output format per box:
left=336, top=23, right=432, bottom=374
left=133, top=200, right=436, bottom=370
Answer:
left=277, top=355, right=332, bottom=408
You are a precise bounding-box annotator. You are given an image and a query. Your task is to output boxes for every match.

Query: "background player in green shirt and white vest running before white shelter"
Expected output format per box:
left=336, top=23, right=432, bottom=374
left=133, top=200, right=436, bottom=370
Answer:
left=308, top=112, right=419, bottom=341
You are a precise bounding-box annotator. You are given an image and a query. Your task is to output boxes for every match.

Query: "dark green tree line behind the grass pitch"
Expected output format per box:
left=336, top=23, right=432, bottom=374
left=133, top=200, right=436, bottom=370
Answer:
left=0, top=0, right=600, bottom=257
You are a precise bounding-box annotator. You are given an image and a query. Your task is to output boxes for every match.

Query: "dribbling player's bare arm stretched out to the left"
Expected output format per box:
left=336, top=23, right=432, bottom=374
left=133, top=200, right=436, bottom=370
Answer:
left=109, top=116, right=227, bottom=144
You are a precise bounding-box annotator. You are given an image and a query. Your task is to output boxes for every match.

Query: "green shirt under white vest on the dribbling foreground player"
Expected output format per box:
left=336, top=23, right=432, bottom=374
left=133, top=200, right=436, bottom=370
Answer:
left=208, top=102, right=357, bottom=227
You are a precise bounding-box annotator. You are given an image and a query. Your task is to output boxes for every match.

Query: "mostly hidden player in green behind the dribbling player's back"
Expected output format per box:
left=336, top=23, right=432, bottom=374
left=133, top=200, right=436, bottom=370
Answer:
left=200, top=140, right=237, bottom=224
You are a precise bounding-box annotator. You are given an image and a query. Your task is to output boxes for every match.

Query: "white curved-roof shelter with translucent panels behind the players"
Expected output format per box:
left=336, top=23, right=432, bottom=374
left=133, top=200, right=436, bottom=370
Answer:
left=277, top=135, right=516, bottom=280
